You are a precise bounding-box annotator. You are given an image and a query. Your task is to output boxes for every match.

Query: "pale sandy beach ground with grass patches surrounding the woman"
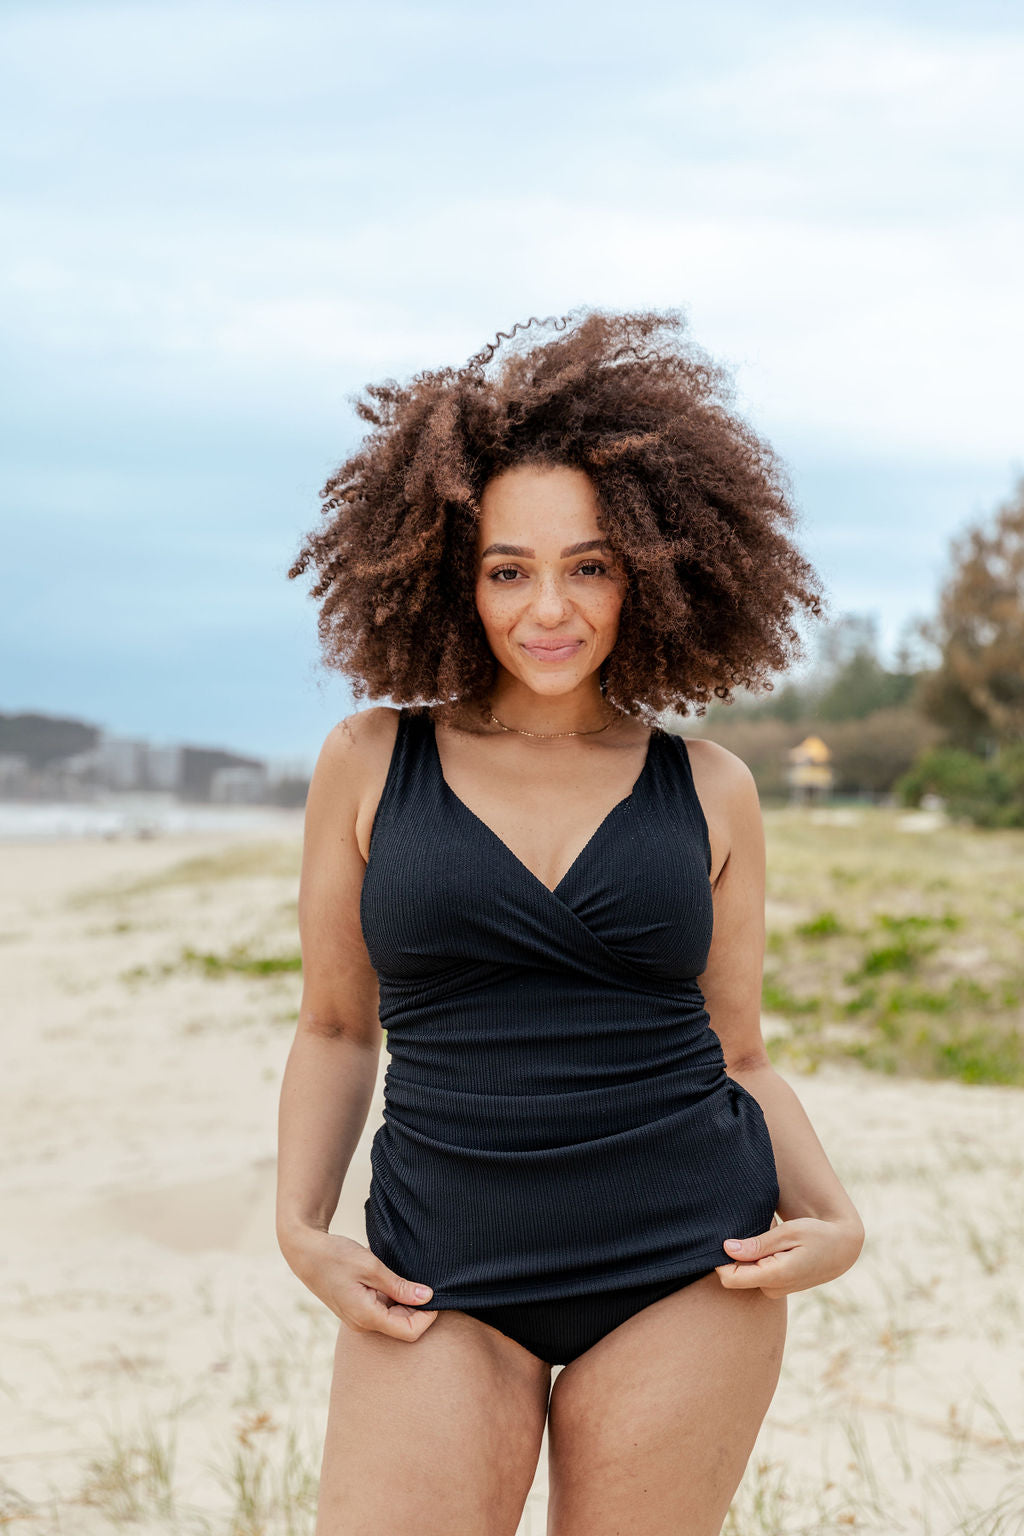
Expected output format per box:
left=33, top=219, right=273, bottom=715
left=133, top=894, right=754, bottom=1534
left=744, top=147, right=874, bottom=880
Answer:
left=0, top=806, right=1024, bottom=1536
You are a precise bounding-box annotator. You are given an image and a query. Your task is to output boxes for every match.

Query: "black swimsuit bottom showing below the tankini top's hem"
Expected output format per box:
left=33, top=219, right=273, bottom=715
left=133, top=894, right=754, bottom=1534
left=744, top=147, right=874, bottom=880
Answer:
left=459, top=1269, right=714, bottom=1366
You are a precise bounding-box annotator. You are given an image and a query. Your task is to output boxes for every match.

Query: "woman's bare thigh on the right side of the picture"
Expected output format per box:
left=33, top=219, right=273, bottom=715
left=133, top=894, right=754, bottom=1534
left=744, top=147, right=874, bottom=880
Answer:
left=548, top=1273, right=788, bottom=1536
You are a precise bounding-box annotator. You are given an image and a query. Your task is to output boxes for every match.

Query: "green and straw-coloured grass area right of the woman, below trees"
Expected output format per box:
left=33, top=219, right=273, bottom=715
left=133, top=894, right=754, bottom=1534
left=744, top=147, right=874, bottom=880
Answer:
left=761, top=806, right=1024, bottom=1084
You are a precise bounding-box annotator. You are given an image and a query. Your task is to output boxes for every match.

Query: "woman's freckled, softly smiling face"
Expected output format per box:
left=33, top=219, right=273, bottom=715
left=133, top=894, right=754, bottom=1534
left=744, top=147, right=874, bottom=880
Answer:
left=476, top=464, right=626, bottom=694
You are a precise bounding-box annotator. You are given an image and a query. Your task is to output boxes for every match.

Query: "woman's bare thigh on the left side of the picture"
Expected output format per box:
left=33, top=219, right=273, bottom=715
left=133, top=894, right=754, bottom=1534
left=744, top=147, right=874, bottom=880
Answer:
left=315, top=1310, right=551, bottom=1536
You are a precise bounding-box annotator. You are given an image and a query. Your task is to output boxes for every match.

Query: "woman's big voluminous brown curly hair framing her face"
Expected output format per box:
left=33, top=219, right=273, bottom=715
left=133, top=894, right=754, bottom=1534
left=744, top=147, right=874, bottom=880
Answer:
left=289, top=309, right=823, bottom=719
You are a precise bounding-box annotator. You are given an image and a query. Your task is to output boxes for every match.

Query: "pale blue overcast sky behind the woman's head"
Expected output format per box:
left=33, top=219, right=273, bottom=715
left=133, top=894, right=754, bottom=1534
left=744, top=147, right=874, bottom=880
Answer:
left=0, top=0, right=1024, bottom=763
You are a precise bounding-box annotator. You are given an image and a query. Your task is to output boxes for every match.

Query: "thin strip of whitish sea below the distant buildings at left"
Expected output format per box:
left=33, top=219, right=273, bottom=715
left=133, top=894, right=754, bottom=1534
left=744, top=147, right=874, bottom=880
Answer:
left=0, top=794, right=302, bottom=843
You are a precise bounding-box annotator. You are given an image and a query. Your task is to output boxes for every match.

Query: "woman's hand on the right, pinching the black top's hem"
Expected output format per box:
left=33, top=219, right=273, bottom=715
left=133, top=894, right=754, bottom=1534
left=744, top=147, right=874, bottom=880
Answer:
left=715, top=1217, right=864, bottom=1296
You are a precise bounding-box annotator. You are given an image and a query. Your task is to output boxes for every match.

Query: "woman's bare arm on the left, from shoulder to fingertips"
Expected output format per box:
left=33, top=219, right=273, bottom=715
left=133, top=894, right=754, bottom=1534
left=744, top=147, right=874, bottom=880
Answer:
left=276, top=708, right=436, bottom=1338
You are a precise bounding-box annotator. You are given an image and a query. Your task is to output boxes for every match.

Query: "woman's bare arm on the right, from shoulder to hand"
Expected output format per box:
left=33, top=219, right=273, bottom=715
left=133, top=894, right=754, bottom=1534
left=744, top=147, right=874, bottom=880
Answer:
left=694, top=742, right=864, bottom=1295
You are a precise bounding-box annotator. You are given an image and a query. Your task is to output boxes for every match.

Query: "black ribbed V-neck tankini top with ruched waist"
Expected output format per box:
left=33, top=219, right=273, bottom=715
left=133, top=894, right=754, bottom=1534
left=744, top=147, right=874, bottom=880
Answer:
left=359, top=710, right=778, bottom=1307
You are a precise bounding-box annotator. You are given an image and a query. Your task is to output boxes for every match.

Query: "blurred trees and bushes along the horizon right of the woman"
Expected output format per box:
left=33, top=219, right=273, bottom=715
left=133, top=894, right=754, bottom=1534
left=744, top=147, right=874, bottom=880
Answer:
left=694, top=476, right=1024, bottom=826
